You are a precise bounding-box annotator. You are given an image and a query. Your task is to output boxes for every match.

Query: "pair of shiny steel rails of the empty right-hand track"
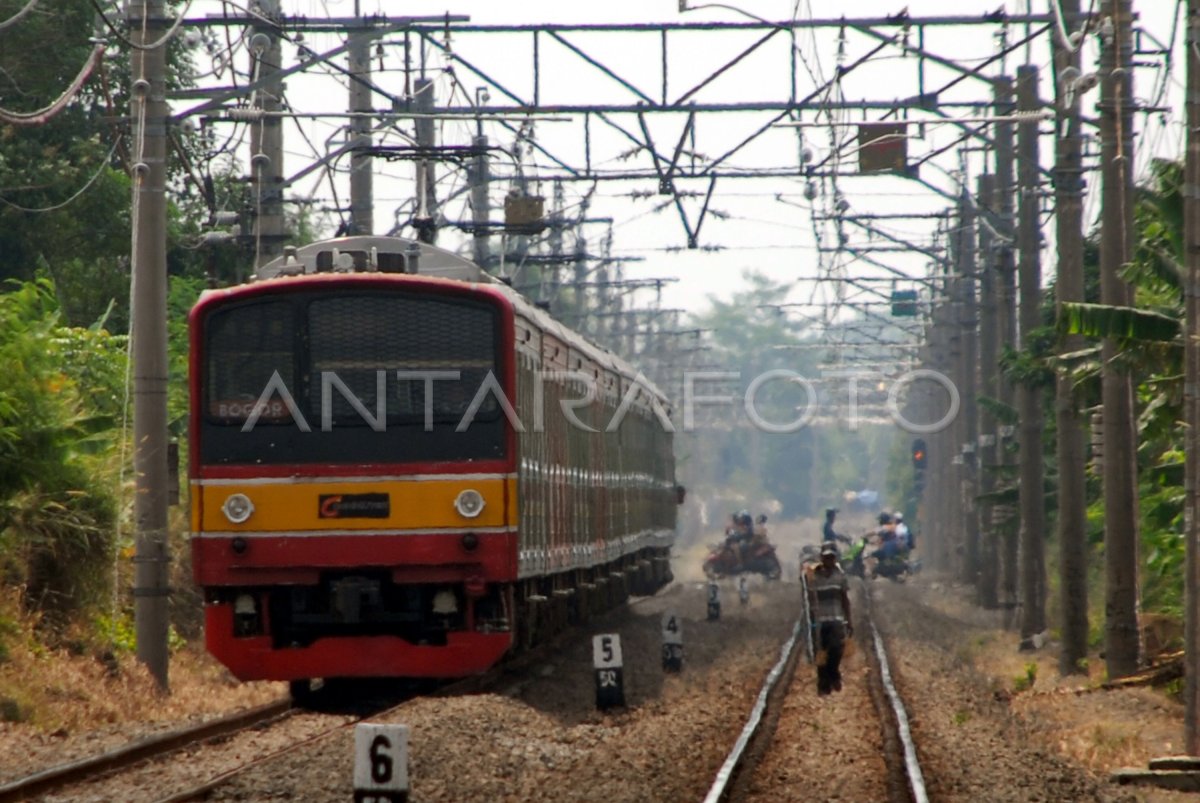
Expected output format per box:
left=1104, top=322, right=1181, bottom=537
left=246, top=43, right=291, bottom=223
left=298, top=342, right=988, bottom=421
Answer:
left=704, top=578, right=929, bottom=803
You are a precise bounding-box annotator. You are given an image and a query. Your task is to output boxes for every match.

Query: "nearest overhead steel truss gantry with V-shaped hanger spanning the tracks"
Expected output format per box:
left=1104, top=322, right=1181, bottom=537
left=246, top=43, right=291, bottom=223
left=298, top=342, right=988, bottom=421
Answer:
left=173, top=12, right=1080, bottom=248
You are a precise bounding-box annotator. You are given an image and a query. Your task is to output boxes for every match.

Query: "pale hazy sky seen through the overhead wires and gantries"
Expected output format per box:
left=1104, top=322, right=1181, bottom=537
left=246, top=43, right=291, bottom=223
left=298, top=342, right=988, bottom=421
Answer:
left=176, top=0, right=1184, bottom=310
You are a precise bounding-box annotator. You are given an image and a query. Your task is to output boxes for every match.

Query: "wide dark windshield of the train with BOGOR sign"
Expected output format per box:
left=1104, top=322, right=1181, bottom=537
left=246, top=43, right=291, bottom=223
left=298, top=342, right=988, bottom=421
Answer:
left=200, top=289, right=505, bottom=463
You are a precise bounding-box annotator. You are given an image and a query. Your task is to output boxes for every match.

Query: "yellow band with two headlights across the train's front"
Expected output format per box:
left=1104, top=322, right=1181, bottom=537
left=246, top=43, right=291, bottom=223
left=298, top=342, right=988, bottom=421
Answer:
left=192, top=478, right=517, bottom=533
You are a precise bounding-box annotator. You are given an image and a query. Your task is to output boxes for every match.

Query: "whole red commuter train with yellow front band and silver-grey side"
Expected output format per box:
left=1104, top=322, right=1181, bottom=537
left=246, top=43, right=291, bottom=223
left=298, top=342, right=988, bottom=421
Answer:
left=188, top=236, right=679, bottom=695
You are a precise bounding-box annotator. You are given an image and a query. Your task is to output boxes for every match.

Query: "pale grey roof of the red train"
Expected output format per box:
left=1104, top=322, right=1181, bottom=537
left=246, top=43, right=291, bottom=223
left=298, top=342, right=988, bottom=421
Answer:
left=226, top=235, right=667, bottom=407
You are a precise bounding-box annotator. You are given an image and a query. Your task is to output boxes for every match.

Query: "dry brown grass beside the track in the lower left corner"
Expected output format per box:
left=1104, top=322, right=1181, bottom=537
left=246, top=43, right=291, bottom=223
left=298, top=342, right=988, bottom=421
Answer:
left=0, top=589, right=284, bottom=733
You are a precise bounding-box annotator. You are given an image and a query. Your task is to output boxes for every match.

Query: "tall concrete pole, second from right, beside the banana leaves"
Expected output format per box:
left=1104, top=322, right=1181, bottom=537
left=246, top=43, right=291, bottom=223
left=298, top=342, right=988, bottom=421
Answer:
left=1100, top=0, right=1140, bottom=678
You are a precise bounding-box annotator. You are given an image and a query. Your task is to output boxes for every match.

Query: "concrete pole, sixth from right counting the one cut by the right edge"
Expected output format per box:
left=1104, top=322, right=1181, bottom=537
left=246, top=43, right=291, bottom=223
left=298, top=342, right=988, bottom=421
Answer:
left=976, top=173, right=1001, bottom=610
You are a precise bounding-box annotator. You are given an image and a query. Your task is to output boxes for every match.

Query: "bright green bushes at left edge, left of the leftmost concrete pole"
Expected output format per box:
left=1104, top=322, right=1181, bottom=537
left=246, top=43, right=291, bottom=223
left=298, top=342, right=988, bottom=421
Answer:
left=0, top=281, right=126, bottom=618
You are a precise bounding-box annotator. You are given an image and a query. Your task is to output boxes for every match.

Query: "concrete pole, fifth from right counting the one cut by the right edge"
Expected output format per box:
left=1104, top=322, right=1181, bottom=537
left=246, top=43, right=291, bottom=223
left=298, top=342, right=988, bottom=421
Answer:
left=994, top=76, right=1019, bottom=611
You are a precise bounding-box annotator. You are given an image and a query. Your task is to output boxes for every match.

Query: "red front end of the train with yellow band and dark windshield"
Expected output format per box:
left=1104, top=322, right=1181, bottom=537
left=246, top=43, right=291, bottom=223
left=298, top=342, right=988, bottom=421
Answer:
left=191, top=276, right=517, bottom=681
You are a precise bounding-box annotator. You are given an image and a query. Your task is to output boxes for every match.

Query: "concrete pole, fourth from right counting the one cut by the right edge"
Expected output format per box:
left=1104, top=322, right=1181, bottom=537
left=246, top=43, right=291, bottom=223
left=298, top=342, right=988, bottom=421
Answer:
left=1016, top=65, right=1046, bottom=648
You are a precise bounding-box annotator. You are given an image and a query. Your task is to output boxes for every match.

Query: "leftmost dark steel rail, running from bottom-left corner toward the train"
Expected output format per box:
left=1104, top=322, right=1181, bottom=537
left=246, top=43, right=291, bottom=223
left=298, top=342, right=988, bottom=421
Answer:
left=0, top=699, right=295, bottom=803
